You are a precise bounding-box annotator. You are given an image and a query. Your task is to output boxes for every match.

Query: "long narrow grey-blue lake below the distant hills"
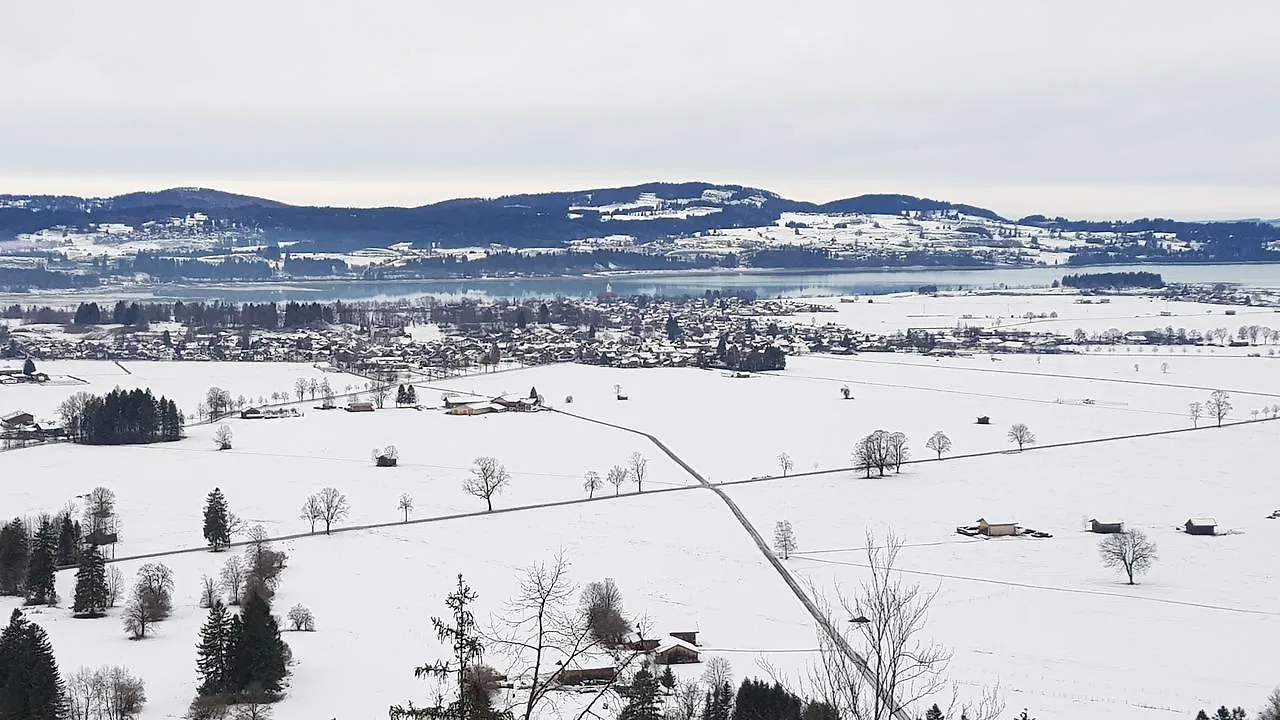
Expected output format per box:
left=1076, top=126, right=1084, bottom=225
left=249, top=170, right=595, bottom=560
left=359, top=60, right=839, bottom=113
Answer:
left=10, top=264, right=1280, bottom=304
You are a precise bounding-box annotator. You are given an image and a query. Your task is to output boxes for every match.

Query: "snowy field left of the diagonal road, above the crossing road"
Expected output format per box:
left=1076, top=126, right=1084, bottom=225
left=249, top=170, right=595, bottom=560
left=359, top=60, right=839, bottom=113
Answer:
left=0, top=409, right=691, bottom=556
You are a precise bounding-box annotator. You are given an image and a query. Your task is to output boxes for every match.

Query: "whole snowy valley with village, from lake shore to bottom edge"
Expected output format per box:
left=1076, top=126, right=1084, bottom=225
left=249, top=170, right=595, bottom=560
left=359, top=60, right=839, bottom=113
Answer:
left=0, top=278, right=1280, bottom=720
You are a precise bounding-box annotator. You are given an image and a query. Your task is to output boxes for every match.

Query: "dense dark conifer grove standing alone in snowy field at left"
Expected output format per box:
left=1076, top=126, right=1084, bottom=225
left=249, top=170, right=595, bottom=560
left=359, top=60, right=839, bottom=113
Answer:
left=58, top=388, right=183, bottom=445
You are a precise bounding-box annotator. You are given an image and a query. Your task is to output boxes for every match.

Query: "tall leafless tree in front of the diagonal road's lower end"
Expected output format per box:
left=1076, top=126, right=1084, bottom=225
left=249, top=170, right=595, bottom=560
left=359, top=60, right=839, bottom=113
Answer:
left=801, top=533, right=1004, bottom=720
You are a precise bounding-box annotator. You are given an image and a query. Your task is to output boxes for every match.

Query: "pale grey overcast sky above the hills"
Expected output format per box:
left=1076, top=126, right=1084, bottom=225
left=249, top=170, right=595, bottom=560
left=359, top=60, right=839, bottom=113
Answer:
left=0, top=0, right=1280, bottom=219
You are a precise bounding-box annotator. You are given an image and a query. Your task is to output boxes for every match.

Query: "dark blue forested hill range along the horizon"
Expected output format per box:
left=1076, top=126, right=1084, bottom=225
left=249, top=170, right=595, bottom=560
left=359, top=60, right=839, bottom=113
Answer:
left=0, top=182, right=1280, bottom=263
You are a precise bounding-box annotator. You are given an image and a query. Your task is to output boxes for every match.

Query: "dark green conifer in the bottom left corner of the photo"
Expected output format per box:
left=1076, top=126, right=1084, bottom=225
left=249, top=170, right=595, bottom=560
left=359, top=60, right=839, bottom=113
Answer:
left=0, top=610, right=67, bottom=720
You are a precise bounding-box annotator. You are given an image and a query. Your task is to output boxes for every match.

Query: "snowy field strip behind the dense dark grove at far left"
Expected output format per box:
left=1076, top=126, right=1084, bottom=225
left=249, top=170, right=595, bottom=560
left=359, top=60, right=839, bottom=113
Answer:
left=0, top=360, right=367, bottom=418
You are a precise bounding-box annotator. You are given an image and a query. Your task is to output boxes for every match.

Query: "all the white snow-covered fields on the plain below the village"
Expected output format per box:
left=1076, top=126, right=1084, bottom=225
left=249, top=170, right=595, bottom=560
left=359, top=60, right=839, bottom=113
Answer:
left=0, top=299, right=1280, bottom=720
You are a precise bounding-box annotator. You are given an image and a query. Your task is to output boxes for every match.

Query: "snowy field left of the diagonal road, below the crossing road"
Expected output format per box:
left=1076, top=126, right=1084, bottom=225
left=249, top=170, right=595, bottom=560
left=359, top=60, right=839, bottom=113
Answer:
left=0, top=489, right=814, bottom=720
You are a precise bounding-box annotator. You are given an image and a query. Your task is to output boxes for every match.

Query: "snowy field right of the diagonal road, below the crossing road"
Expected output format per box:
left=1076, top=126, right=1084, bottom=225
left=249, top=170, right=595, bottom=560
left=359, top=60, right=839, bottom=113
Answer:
left=728, top=423, right=1280, bottom=719
